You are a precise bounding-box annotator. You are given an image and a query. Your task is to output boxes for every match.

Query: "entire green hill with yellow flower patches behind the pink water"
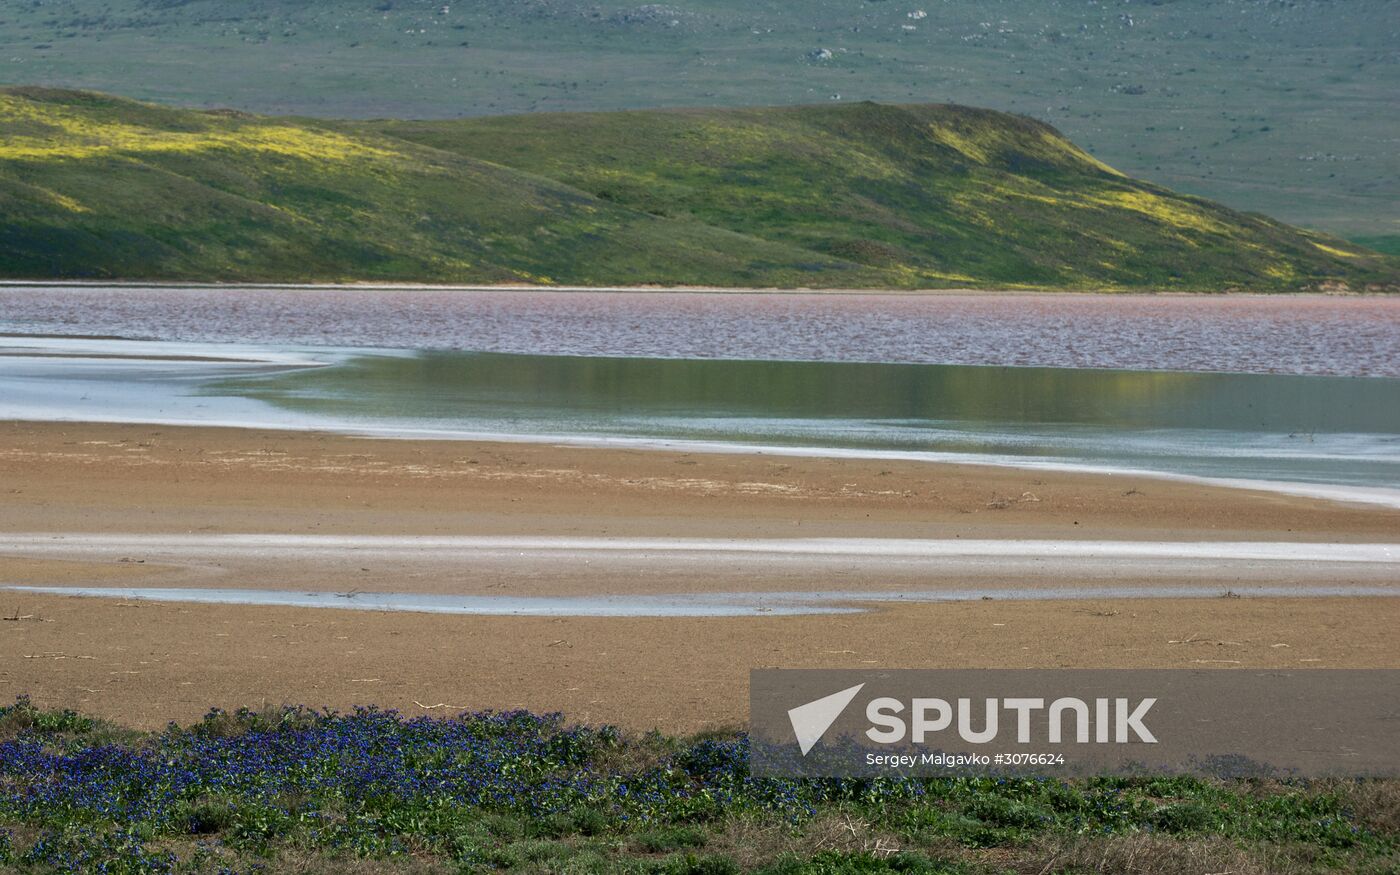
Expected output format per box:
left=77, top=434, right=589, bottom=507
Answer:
left=0, top=88, right=1400, bottom=290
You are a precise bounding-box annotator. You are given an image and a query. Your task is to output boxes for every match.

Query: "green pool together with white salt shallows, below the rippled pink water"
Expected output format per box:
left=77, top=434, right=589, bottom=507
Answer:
left=8, top=337, right=1400, bottom=507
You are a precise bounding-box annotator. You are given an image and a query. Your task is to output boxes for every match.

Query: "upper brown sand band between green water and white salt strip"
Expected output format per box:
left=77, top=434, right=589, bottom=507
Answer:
left=0, top=420, right=1400, bottom=540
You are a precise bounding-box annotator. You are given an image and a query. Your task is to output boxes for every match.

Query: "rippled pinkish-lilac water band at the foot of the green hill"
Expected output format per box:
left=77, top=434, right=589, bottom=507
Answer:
left=0, top=284, right=1400, bottom=377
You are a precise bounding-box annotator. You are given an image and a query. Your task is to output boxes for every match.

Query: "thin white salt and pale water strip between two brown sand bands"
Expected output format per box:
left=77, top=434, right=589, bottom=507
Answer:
left=0, top=533, right=1400, bottom=607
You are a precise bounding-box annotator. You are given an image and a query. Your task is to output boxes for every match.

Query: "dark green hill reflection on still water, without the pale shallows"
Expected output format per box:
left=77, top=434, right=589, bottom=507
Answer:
left=235, top=351, right=1400, bottom=433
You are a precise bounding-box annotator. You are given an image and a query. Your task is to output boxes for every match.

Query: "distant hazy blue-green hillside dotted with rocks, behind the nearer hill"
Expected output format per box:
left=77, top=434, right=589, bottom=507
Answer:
left=0, top=0, right=1400, bottom=235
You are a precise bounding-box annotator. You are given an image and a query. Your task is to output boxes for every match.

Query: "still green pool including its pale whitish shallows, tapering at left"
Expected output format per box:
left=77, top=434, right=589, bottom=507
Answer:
left=226, top=351, right=1400, bottom=487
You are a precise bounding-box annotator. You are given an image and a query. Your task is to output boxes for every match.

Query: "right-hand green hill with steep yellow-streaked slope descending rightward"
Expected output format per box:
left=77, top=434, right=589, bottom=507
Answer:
left=374, top=104, right=1383, bottom=288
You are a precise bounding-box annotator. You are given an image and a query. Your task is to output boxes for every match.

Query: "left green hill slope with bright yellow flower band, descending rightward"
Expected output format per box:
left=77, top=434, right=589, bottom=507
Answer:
left=0, top=90, right=876, bottom=284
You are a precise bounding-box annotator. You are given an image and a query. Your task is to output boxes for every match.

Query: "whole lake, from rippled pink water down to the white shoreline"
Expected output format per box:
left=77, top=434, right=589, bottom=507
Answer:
left=0, top=287, right=1400, bottom=495
